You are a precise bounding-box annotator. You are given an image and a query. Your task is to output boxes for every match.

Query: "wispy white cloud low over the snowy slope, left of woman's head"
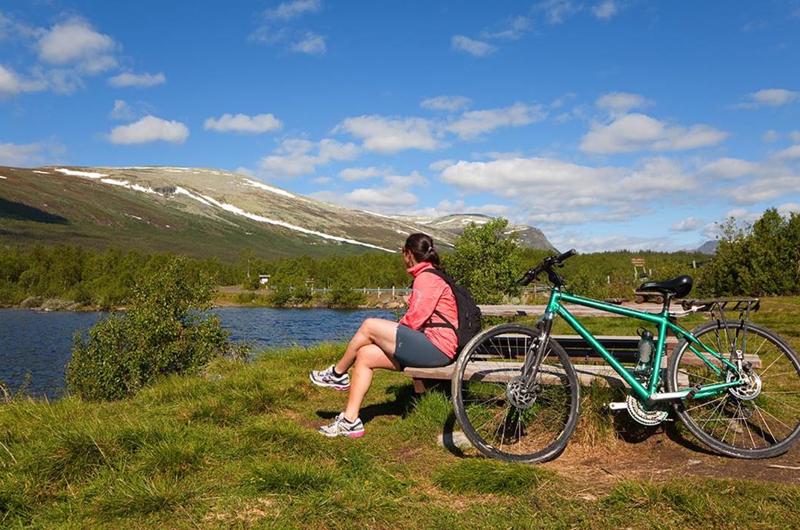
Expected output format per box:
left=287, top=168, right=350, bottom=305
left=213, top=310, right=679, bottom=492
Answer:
left=259, top=138, right=359, bottom=178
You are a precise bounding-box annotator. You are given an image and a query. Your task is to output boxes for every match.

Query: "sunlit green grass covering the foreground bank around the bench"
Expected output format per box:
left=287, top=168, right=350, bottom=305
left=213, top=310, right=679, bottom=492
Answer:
left=0, top=298, right=800, bottom=529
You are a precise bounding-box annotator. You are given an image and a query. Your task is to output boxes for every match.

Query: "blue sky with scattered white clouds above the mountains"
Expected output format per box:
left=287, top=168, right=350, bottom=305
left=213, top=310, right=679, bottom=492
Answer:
left=0, top=0, right=800, bottom=251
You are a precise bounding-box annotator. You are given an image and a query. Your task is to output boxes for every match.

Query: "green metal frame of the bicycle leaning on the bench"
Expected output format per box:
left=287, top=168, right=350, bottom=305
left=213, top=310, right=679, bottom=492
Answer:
left=542, top=287, right=742, bottom=403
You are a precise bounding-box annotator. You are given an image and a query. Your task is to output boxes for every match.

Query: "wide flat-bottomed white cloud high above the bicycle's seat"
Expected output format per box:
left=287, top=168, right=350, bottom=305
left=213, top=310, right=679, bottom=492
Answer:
left=580, top=114, right=728, bottom=154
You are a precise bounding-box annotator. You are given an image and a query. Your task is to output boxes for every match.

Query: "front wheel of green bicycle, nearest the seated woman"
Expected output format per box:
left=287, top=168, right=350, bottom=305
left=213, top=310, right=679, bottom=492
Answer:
left=452, top=324, right=580, bottom=463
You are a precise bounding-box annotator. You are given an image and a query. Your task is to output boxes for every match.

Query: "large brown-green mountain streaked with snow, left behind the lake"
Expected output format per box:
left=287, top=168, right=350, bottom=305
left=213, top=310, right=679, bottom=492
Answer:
left=0, top=166, right=552, bottom=260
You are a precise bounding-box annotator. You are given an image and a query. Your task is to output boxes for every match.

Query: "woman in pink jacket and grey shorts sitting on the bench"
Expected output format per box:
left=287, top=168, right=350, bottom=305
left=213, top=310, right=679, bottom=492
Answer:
left=309, top=234, right=458, bottom=438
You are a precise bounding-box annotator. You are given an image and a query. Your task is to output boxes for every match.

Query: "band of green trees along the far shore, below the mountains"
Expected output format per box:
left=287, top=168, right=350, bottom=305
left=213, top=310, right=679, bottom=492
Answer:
left=0, top=205, right=800, bottom=308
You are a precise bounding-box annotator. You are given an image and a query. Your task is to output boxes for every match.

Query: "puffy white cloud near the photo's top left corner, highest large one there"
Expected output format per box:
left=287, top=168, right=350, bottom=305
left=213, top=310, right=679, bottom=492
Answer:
left=38, top=18, right=117, bottom=74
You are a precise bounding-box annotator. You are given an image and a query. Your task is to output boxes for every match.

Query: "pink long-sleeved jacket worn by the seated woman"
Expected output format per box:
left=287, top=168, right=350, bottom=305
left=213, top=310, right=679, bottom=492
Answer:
left=400, top=261, right=458, bottom=359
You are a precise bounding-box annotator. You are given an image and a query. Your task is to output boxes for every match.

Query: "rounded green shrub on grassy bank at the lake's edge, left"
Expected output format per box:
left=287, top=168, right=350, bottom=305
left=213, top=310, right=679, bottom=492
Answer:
left=67, top=258, right=230, bottom=400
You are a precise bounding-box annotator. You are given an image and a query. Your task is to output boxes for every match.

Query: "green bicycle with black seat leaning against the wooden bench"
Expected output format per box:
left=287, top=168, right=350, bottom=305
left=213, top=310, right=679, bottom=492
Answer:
left=452, top=250, right=800, bottom=462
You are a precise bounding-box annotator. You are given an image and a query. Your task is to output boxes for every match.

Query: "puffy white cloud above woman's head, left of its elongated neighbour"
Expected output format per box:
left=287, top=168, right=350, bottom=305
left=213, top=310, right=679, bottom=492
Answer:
left=334, top=115, right=441, bottom=153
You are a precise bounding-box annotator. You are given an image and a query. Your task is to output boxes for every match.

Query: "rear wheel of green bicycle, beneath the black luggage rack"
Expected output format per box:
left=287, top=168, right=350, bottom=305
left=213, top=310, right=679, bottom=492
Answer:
left=667, top=321, right=800, bottom=458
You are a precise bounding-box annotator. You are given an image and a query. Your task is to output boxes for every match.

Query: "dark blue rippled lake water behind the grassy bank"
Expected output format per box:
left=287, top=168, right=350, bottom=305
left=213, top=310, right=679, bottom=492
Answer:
left=0, top=307, right=397, bottom=398
